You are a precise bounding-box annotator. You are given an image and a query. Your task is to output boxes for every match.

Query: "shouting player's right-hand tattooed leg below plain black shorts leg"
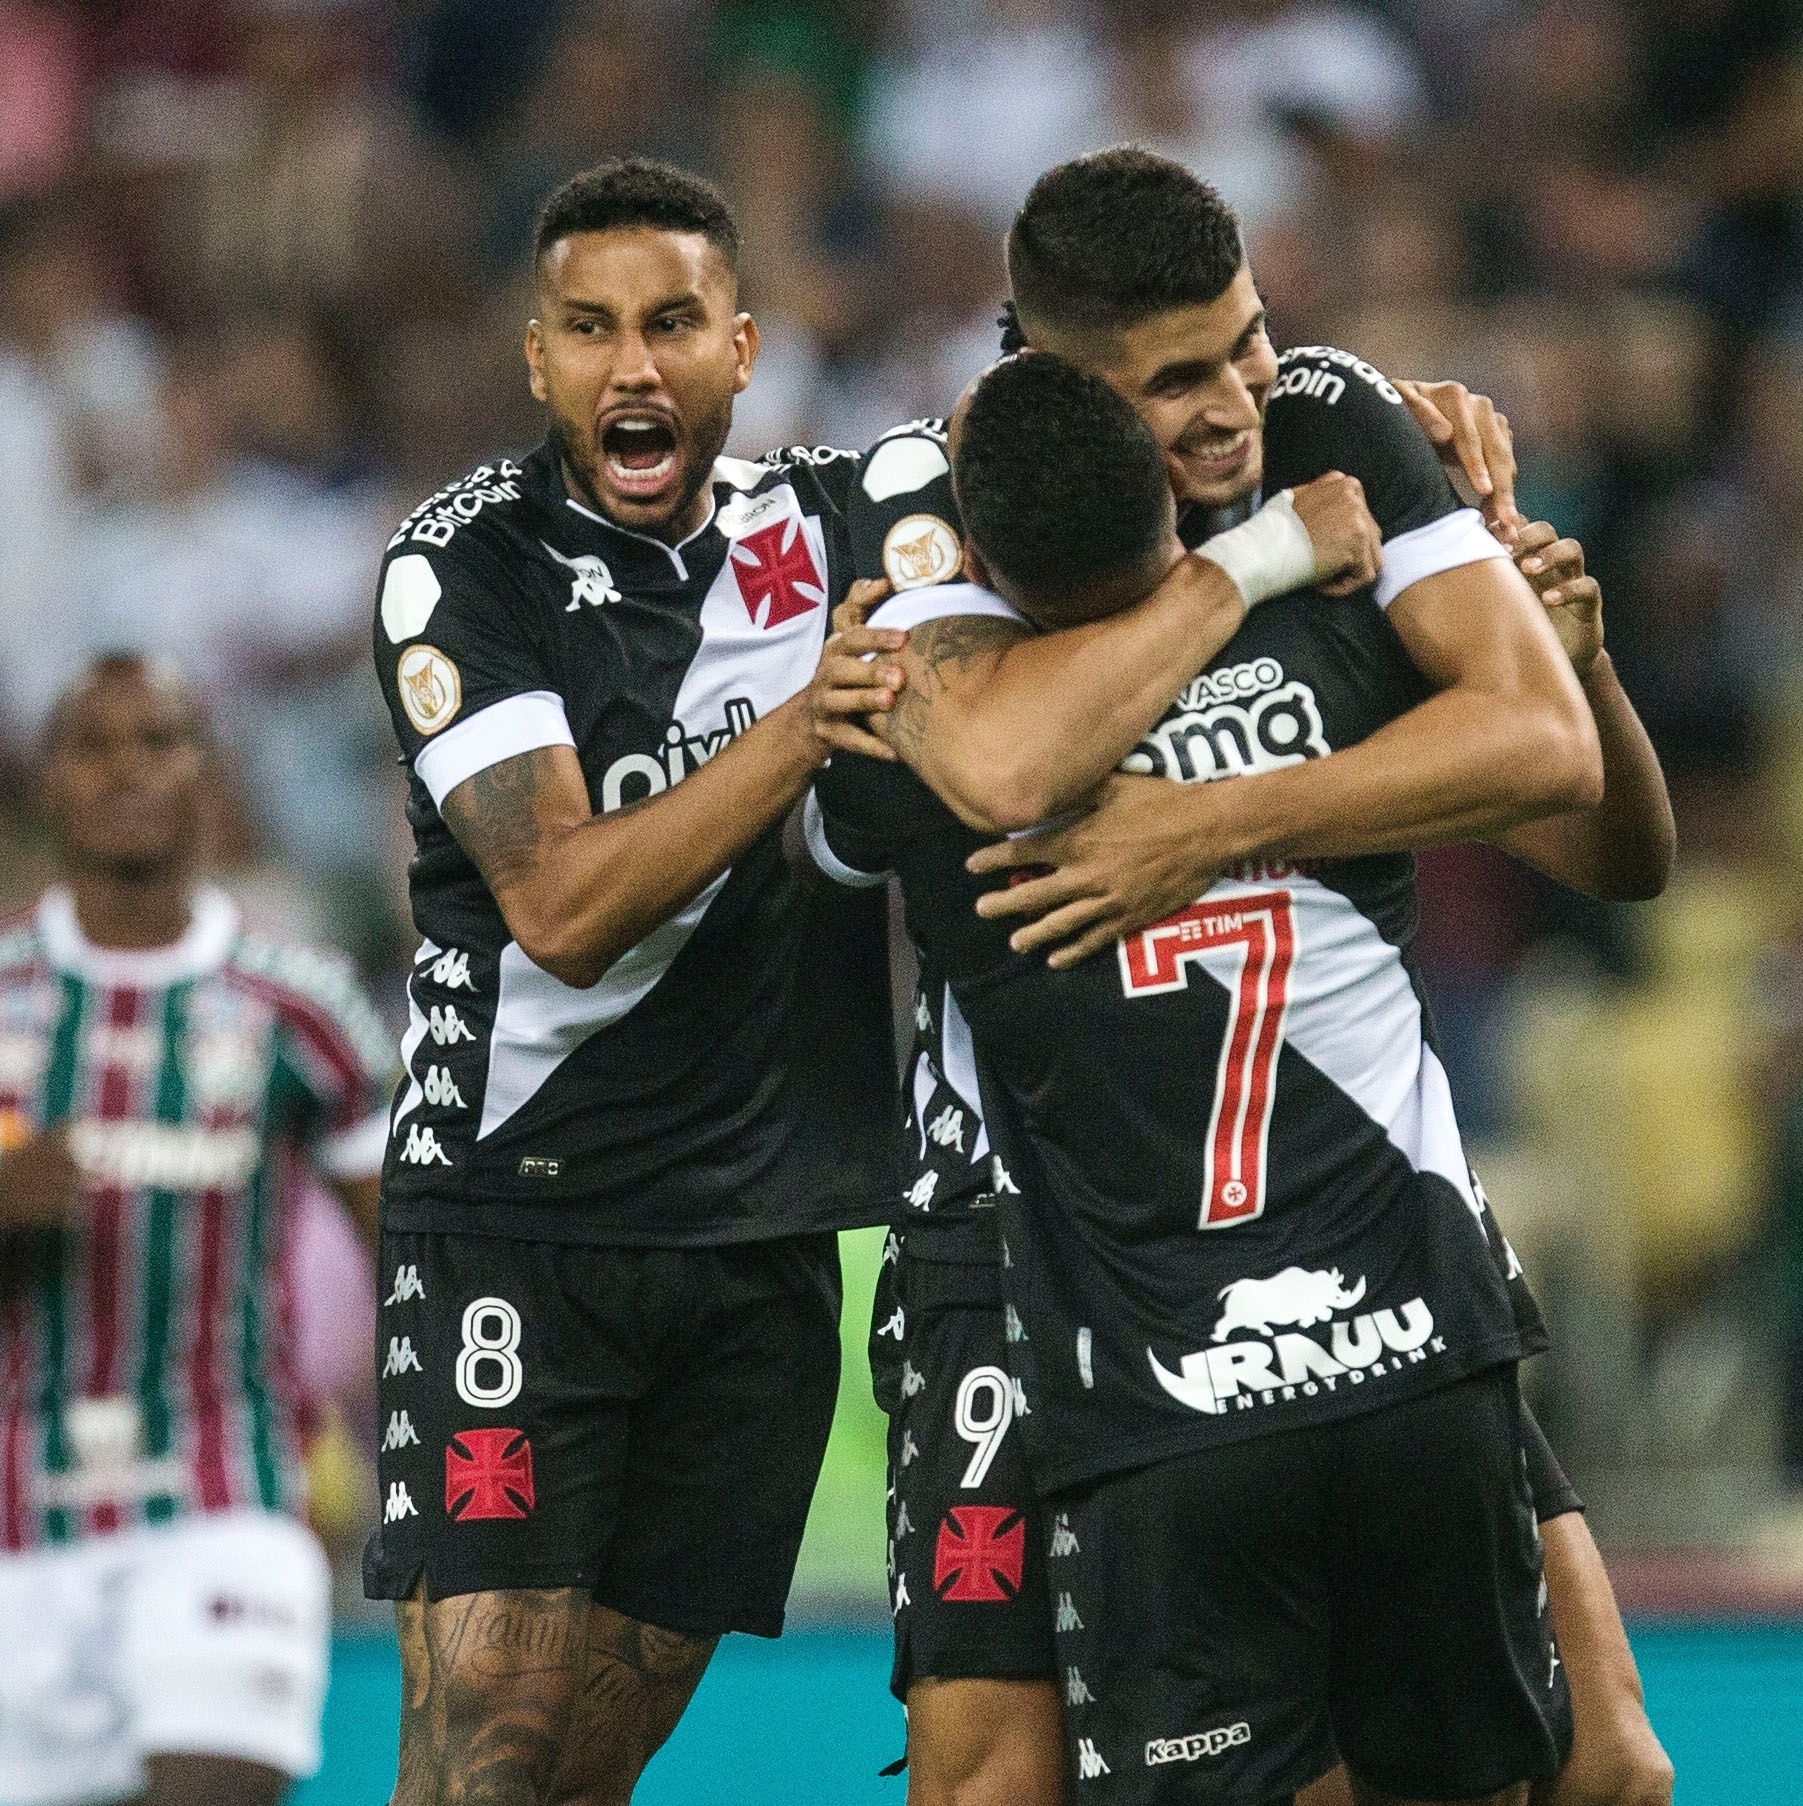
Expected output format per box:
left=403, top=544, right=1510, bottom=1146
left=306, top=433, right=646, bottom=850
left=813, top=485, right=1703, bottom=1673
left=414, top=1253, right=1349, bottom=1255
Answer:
left=551, top=1606, right=719, bottom=1806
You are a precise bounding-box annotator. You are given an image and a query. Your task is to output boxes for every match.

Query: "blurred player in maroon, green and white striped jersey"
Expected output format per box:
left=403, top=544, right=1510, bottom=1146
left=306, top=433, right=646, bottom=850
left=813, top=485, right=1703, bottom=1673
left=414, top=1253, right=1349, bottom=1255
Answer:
left=0, top=656, right=394, bottom=1806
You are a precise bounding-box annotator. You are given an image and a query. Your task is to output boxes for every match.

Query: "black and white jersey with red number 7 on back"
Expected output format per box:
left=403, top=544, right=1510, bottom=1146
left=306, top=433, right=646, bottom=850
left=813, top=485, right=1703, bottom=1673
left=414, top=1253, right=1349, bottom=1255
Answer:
left=817, top=347, right=1541, bottom=1488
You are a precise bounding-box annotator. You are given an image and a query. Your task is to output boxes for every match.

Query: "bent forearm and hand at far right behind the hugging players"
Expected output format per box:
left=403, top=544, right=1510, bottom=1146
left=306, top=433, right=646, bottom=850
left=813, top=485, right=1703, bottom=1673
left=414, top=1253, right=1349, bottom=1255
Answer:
left=1498, top=520, right=1677, bottom=903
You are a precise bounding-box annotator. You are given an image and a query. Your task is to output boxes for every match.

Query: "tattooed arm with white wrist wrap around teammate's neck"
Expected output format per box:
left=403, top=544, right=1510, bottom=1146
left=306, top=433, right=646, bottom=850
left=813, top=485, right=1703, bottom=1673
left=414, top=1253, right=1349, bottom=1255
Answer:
left=882, top=473, right=1378, bottom=833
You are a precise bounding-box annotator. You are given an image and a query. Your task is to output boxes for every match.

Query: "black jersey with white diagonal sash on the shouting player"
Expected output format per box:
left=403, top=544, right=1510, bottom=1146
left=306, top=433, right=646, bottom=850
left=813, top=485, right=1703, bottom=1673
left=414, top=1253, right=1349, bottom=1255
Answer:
left=374, top=448, right=894, bottom=1244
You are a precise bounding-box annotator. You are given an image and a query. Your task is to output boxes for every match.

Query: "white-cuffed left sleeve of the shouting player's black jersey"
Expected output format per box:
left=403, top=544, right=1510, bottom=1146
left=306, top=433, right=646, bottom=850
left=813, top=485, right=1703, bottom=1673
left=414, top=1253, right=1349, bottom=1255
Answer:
left=374, top=502, right=575, bottom=804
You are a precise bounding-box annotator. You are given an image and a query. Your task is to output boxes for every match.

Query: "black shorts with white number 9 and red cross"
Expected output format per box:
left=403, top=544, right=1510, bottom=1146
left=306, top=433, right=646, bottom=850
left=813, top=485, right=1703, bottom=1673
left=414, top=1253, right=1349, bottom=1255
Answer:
left=871, top=1217, right=1055, bottom=1701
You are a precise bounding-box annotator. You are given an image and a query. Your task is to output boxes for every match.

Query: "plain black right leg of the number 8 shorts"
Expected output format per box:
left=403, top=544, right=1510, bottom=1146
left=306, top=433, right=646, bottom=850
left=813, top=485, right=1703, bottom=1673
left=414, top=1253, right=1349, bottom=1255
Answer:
left=593, top=1233, right=840, bottom=1636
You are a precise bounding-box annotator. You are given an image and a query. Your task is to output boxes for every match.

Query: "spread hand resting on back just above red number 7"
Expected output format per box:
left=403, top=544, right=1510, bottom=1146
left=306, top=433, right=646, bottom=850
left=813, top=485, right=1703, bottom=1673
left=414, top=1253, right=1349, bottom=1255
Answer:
left=965, top=777, right=1218, bottom=970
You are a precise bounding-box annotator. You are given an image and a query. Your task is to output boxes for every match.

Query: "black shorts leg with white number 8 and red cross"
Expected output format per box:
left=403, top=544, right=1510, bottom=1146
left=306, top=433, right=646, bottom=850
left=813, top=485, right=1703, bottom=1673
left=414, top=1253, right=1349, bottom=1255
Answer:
left=363, top=1232, right=643, bottom=1600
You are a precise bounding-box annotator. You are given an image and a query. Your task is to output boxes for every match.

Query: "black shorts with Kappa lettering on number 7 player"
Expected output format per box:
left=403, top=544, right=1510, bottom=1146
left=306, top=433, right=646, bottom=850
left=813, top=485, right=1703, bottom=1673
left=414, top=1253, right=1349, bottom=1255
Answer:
left=1051, top=1365, right=1570, bottom=1806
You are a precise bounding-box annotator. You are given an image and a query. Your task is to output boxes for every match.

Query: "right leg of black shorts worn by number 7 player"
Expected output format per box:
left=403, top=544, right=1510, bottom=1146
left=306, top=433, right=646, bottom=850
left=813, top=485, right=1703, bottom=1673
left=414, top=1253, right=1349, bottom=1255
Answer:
left=1317, top=1365, right=1570, bottom=1801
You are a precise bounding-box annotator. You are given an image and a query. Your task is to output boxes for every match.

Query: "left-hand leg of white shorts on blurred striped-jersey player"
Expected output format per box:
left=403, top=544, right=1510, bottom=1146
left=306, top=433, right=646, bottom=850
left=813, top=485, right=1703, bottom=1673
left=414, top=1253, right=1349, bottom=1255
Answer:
left=0, top=1537, right=143, bottom=1806
